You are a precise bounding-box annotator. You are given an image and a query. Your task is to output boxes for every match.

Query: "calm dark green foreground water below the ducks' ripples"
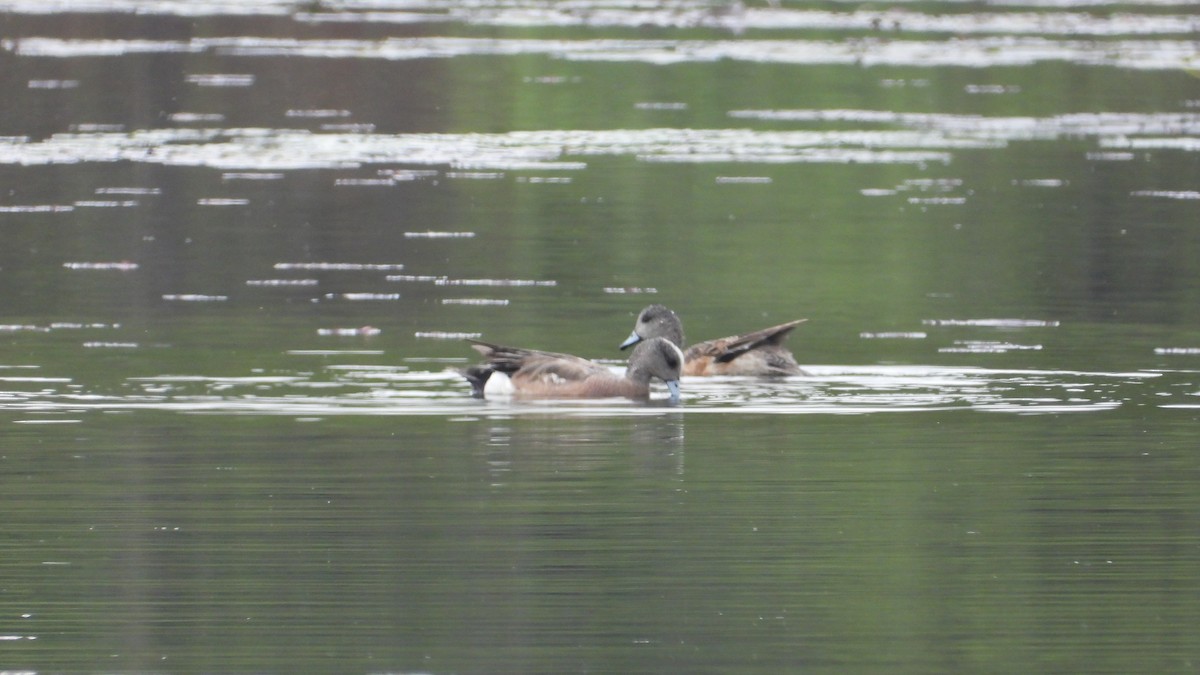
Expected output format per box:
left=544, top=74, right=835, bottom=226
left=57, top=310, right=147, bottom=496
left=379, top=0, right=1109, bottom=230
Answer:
left=4, top=412, right=1200, bottom=673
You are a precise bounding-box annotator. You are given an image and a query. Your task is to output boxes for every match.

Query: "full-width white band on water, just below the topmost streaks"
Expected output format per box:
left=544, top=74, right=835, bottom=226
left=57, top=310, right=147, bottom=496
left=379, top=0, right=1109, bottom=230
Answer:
left=9, top=35, right=1200, bottom=70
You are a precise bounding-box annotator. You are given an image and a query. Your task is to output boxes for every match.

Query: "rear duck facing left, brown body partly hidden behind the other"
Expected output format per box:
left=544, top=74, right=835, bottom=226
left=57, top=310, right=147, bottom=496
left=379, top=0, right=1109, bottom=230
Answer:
left=620, top=305, right=808, bottom=376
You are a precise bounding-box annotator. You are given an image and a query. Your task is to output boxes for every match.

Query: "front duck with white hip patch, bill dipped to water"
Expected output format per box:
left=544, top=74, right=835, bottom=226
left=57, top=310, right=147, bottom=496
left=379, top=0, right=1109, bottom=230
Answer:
left=462, top=338, right=683, bottom=402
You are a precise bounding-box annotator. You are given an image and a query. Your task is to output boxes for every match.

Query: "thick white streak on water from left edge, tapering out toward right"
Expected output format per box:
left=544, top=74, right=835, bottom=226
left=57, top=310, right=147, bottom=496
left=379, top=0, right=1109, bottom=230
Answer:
left=0, top=129, right=964, bottom=169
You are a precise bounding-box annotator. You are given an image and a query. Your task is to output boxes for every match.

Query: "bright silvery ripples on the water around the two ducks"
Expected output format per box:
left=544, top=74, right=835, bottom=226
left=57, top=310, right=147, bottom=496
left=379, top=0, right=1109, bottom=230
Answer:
left=0, top=362, right=1166, bottom=417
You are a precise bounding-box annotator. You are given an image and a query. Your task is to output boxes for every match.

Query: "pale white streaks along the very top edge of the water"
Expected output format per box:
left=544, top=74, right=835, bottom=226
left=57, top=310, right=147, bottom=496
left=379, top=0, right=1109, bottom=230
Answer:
left=0, top=0, right=1200, bottom=36
